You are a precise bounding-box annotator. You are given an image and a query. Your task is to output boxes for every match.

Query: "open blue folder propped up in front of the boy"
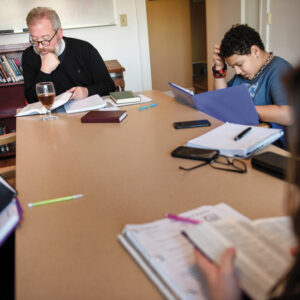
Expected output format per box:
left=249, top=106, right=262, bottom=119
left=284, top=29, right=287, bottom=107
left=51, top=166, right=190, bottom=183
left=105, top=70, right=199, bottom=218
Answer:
left=169, top=83, right=259, bottom=125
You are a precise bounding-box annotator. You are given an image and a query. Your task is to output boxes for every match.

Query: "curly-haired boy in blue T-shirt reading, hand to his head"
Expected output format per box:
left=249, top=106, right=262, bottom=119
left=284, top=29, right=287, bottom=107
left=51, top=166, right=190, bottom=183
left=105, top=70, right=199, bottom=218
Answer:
left=213, top=25, right=292, bottom=126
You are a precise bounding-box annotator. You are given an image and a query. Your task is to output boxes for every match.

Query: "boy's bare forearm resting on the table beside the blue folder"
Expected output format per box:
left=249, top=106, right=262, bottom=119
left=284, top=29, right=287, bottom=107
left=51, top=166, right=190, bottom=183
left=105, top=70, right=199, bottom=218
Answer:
left=256, top=105, right=293, bottom=126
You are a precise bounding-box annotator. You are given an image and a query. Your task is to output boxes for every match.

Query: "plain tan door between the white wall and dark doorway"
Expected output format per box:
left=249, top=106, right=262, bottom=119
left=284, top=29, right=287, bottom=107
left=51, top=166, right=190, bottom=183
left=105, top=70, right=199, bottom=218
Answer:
left=146, top=0, right=192, bottom=91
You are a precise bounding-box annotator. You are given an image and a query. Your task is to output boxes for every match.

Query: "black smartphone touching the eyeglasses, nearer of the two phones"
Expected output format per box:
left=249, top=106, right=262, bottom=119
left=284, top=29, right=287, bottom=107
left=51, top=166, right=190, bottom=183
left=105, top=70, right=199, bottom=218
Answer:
left=171, top=146, right=219, bottom=162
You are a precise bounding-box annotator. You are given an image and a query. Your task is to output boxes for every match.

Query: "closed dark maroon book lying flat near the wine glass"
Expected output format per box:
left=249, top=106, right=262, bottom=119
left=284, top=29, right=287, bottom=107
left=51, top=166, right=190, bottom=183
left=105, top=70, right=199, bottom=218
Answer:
left=81, top=110, right=127, bottom=123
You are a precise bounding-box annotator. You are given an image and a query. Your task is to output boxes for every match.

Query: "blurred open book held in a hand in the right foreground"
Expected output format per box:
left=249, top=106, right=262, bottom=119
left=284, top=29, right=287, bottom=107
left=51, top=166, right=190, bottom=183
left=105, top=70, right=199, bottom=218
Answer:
left=184, top=217, right=297, bottom=300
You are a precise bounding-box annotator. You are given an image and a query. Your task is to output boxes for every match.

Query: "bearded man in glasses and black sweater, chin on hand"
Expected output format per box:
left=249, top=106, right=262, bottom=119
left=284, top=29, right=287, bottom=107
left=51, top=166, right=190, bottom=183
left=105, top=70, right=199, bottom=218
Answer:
left=22, top=7, right=115, bottom=103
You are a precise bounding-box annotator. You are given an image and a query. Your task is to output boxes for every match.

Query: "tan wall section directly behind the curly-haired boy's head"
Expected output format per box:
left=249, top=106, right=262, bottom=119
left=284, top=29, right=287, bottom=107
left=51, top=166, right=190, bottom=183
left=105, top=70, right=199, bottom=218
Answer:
left=206, top=0, right=241, bottom=90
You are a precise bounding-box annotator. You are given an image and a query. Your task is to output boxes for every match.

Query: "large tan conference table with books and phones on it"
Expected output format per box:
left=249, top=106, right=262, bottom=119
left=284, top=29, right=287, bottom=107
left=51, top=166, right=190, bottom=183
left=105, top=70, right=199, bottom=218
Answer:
left=16, top=91, right=286, bottom=300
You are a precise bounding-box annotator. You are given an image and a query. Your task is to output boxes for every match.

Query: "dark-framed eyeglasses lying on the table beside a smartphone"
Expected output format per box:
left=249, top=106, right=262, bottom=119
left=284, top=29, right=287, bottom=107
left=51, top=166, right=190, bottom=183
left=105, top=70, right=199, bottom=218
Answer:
left=179, top=155, right=247, bottom=173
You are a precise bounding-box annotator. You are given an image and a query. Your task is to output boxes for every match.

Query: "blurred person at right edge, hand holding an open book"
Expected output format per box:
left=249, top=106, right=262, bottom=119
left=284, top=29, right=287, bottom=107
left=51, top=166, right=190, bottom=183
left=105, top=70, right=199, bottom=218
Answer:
left=195, top=67, right=300, bottom=300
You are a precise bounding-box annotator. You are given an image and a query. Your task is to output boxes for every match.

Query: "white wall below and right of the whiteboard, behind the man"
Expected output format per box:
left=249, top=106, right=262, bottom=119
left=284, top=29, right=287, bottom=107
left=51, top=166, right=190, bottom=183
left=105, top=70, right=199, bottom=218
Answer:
left=0, top=0, right=152, bottom=91
